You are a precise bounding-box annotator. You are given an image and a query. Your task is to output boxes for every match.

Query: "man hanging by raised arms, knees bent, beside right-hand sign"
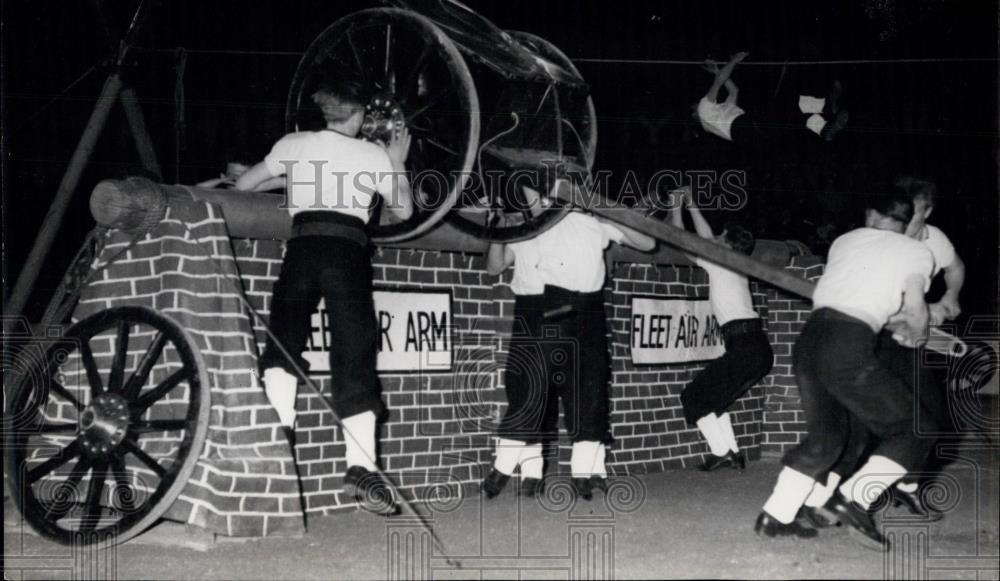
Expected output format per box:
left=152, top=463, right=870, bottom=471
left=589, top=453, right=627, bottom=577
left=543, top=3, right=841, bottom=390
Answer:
left=671, top=188, right=774, bottom=472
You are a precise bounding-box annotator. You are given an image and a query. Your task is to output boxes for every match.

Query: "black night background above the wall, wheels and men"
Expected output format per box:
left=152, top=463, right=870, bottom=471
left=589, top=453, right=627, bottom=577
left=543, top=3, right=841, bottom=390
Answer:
left=2, top=0, right=998, bottom=322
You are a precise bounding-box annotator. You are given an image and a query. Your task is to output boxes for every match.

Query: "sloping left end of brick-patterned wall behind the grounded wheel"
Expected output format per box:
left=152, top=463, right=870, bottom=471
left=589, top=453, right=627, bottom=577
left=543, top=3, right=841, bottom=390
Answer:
left=74, top=202, right=302, bottom=536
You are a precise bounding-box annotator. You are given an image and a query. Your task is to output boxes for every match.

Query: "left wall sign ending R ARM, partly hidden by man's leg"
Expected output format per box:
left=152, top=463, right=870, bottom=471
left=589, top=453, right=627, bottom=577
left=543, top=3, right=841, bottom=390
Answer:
left=302, top=291, right=452, bottom=373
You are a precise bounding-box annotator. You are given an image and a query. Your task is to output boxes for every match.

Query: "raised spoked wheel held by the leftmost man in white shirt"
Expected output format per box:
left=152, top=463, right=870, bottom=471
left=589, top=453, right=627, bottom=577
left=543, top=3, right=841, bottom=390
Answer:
left=286, top=8, right=479, bottom=243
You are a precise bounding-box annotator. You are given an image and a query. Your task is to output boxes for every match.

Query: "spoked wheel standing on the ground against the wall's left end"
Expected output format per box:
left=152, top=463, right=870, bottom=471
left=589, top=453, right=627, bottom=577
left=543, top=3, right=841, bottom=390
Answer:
left=4, top=307, right=210, bottom=546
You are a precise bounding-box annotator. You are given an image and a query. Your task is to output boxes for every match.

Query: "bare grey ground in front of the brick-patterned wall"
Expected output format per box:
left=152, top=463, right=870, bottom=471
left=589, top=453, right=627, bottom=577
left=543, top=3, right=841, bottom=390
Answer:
left=4, top=454, right=1000, bottom=580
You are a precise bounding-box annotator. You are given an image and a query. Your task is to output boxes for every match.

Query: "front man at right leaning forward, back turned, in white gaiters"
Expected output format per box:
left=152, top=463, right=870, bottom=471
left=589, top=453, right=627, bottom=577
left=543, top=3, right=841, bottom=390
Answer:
left=754, top=188, right=934, bottom=550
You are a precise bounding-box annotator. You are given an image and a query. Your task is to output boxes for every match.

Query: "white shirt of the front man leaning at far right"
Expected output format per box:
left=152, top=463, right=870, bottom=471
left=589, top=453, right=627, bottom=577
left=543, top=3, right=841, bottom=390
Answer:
left=813, top=228, right=934, bottom=332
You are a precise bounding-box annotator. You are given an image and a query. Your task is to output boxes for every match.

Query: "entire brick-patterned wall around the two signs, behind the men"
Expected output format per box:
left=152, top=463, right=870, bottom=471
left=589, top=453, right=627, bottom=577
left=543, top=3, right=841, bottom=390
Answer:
left=66, top=199, right=822, bottom=535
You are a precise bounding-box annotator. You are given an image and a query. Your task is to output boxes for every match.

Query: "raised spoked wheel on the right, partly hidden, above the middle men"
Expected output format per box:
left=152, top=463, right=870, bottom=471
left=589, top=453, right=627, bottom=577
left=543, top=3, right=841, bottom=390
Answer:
left=448, top=30, right=597, bottom=242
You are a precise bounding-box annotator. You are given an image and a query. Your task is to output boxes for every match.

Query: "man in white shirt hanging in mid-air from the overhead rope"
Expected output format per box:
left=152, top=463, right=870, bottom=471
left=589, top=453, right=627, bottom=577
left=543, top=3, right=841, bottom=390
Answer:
left=696, top=52, right=848, bottom=146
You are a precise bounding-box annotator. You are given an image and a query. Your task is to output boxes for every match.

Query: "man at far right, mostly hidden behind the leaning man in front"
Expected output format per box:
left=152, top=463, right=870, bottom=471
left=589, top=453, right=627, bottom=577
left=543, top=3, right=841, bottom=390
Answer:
left=792, top=176, right=965, bottom=527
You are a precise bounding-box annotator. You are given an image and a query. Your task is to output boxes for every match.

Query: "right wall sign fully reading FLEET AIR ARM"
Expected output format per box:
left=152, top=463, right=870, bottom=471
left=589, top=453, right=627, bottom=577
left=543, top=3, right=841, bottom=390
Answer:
left=629, top=297, right=726, bottom=365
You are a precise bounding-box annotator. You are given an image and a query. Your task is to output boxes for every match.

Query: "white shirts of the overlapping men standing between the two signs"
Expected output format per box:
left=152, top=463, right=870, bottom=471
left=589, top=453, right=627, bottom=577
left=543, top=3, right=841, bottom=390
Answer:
left=509, top=212, right=625, bottom=294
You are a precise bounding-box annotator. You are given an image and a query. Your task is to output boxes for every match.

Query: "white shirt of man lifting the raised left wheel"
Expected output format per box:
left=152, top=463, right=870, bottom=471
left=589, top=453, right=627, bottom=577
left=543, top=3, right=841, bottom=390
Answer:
left=264, top=130, right=393, bottom=224
